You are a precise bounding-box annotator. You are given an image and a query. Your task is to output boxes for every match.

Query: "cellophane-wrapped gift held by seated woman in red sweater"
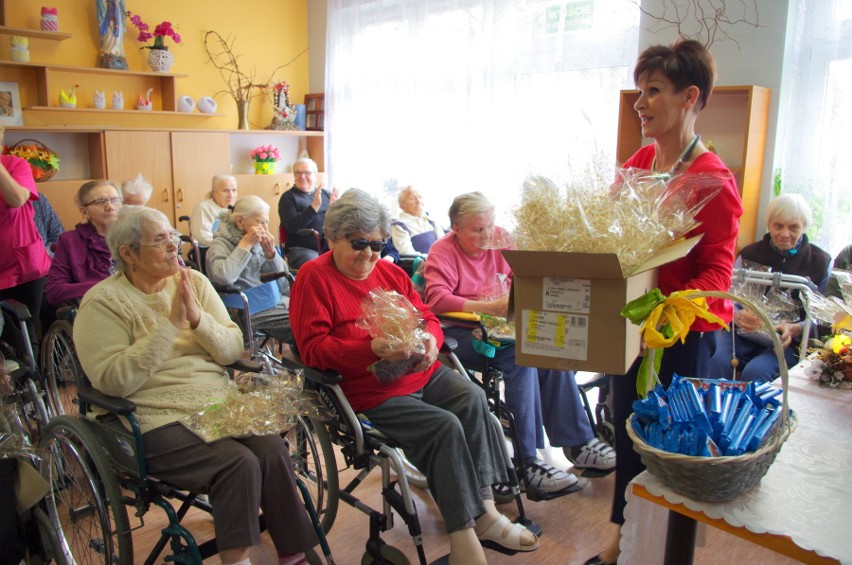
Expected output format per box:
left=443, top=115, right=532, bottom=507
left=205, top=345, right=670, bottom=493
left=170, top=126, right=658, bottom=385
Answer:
left=356, top=288, right=428, bottom=385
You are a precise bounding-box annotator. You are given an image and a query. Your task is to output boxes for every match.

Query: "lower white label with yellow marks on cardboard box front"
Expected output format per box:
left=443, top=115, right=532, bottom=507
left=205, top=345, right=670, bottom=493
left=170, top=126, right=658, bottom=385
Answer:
left=521, top=310, right=589, bottom=361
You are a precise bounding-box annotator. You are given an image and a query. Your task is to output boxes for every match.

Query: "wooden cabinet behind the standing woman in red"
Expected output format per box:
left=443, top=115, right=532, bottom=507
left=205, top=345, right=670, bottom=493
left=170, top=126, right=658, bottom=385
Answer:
left=616, top=85, right=770, bottom=249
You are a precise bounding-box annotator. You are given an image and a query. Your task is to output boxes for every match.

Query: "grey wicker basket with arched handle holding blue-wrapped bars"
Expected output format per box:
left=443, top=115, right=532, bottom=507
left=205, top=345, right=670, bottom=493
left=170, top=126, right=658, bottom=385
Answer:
left=627, top=291, right=796, bottom=501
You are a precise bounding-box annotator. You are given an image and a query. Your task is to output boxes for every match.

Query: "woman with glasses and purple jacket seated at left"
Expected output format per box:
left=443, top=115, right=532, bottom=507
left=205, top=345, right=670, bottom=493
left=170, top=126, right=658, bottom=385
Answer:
left=44, top=180, right=121, bottom=306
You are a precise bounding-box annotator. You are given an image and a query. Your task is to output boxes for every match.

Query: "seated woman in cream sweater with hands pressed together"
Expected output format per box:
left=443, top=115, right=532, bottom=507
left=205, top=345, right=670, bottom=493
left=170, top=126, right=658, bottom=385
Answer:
left=74, top=206, right=317, bottom=563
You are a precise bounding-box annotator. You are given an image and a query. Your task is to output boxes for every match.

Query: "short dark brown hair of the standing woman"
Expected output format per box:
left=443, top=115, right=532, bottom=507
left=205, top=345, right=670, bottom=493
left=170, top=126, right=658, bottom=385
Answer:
left=633, top=39, right=716, bottom=111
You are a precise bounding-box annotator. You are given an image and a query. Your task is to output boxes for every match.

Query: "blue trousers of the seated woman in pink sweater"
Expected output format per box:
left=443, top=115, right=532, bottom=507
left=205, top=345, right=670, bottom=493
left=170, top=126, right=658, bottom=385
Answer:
left=444, top=328, right=595, bottom=461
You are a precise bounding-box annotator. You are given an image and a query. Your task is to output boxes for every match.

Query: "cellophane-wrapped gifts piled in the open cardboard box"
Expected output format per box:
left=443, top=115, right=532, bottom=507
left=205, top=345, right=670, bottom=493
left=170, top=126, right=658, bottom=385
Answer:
left=514, top=168, right=729, bottom=276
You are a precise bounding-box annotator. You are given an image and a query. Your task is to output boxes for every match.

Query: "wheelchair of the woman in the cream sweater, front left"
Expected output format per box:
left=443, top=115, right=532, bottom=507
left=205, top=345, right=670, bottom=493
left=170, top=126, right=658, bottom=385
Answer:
left=39, top=350, right=333, bottom=564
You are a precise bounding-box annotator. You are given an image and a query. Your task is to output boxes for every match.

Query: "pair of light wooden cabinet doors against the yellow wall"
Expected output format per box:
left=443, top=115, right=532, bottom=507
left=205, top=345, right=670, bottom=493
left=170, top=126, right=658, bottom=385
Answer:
left=104, top=130, right=230, bottom=229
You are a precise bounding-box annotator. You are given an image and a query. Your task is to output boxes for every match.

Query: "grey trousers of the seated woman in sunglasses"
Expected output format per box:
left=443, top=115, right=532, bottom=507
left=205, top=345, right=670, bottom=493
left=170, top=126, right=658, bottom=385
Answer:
left=364, top=366, right=509, bottom=532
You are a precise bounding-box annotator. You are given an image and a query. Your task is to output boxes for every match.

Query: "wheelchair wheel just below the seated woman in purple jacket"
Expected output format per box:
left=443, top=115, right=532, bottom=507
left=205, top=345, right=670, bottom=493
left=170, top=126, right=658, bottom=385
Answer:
left=41, top=320, right=83, bottom=416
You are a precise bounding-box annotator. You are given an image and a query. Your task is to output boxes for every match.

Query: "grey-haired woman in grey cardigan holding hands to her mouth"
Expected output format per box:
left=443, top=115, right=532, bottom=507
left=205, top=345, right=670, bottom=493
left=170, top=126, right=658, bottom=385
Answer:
left=206, top=196, right=292, bottom=343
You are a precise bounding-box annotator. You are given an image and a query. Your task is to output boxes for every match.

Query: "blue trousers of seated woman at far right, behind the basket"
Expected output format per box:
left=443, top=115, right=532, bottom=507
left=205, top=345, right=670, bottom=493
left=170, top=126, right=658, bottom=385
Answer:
left=708, top=330, right=798, bottom=382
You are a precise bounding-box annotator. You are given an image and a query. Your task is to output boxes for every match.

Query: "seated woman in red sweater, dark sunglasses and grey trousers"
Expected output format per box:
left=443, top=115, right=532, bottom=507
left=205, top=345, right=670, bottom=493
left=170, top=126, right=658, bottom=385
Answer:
left=290, top=189, right=539, bottom=564
